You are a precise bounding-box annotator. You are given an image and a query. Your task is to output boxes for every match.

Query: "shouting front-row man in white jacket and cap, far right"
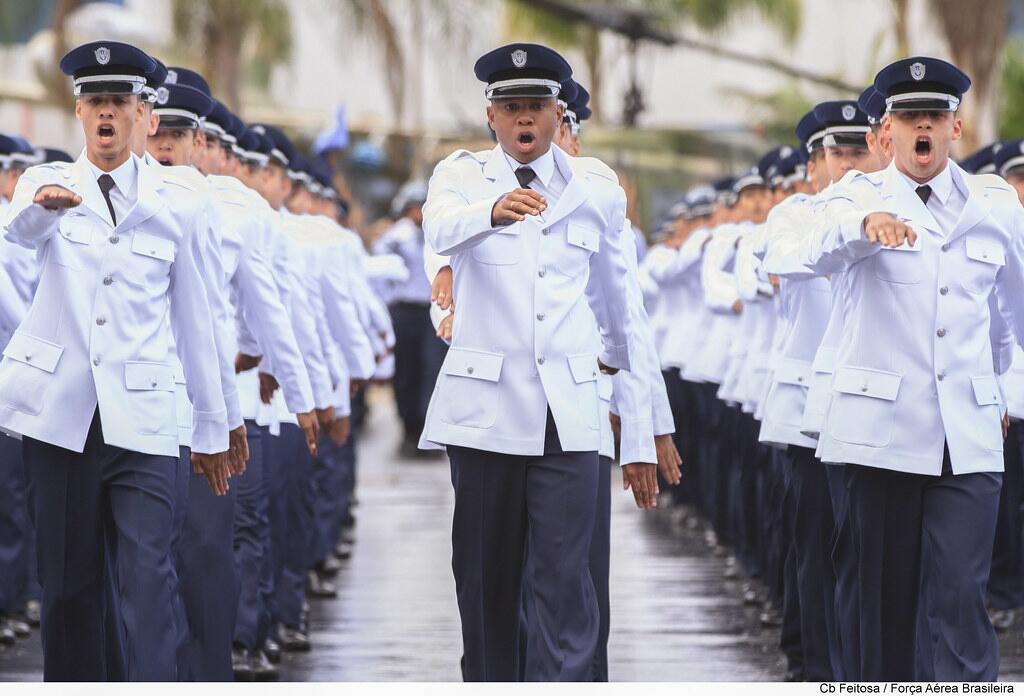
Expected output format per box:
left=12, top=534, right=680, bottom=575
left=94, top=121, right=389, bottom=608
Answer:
left=810, top=57, right=1024, bottom=681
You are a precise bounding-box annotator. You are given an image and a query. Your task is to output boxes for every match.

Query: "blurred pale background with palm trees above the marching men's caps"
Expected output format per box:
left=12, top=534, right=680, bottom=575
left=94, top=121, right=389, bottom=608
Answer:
left=0, top=0, right=1024, bottom=234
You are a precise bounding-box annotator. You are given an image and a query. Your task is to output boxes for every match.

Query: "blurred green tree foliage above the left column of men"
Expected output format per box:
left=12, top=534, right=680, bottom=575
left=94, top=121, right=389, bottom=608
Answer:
left=171, top=0, right=292, bottom=111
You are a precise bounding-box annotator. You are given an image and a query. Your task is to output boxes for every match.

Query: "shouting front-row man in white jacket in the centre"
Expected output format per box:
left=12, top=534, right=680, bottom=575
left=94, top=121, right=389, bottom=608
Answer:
left=424, top=44, right=630, bottom=681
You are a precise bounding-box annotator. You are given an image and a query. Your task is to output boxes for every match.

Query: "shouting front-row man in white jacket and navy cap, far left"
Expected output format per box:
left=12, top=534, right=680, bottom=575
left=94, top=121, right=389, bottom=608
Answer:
left=0, top=42, right=227, bottom=681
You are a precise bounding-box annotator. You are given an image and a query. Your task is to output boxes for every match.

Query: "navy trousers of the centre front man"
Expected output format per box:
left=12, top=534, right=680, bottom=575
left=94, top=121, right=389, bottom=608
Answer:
left=449, top=414, right=600, bottom=682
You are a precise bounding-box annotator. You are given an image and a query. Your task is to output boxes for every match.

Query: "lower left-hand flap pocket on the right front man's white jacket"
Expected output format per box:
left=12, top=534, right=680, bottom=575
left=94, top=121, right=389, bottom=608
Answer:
left=828, top=366, right=903, bottom=447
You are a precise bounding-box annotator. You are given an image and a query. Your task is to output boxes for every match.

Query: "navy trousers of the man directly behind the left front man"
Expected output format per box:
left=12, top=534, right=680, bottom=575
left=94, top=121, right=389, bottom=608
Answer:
left=174, top=446, right=239, bottom=682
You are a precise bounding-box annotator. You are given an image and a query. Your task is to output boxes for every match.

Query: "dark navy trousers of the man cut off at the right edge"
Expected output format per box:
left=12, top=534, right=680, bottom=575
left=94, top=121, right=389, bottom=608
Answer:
left=988, top=419, right=1024, bottom=609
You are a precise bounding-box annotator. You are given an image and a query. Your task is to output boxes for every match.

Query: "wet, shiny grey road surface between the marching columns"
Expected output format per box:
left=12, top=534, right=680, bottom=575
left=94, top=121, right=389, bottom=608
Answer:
left=6, top=392, right=1024, bottom=682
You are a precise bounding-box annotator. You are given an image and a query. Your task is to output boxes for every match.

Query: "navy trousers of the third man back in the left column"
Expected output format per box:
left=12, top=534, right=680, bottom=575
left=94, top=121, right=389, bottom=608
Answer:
left=231, top=421, right=271, bottom=650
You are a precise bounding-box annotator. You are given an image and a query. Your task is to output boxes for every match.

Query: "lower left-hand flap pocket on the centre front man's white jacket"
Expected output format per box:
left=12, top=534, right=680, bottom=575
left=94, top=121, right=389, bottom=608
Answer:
left=440, top=346, right=505, bottom=428
